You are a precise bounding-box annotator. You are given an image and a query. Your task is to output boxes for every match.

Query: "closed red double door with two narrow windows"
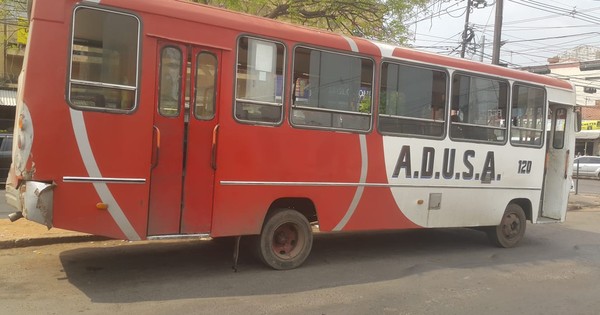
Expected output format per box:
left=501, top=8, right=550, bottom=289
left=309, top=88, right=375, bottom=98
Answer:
left=147, top=41, right=221, bottom=236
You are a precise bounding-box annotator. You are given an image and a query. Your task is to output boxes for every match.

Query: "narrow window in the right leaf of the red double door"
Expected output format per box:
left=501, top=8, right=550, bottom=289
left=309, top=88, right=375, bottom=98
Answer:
left=194, top=52, right=217, bottom=120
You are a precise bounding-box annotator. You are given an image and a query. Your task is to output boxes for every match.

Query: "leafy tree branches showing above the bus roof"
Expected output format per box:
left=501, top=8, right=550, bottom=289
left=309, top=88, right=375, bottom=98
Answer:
left=190, top=0, right=429, bottom=44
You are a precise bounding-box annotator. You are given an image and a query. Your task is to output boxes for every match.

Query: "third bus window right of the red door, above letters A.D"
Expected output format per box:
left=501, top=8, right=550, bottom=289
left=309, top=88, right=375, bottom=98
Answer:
left=379, top=62, right=447, bottom=138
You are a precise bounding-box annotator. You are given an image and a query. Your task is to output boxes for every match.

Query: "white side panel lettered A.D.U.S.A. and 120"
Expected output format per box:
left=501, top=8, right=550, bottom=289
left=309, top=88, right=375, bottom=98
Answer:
left=384, top=136, right=544, bottom=227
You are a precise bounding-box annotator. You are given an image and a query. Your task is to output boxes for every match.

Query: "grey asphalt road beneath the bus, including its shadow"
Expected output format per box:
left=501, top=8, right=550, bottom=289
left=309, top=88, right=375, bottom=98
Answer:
left=0, top=208, right=600, bottom=315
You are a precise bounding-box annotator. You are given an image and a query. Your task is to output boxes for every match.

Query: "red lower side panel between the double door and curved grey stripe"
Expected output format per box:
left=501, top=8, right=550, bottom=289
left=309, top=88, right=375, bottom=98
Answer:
left=212, top=121, right=361, bottom=236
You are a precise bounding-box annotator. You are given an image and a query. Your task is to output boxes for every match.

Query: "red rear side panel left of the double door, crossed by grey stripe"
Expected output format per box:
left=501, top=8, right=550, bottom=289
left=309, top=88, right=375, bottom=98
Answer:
left=14, top=1, right=154, bottom=239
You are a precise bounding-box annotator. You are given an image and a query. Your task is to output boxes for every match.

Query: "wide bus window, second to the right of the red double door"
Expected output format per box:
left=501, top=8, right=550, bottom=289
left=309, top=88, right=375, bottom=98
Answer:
left=291, top=47, right=373, bottom=131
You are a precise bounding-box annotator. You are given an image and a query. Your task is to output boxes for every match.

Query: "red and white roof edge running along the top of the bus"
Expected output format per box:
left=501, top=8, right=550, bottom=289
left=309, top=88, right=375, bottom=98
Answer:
left=101, top=0, right=573, bottom=90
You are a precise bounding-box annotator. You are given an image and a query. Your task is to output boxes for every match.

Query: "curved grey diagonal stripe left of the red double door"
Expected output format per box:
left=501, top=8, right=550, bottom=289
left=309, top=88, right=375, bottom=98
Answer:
left=69, top=108, right=141, bottom=241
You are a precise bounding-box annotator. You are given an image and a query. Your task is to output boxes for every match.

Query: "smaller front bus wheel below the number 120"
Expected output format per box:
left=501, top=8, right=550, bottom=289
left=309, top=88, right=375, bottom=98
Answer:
left=487, top=203, right=527, bottom=248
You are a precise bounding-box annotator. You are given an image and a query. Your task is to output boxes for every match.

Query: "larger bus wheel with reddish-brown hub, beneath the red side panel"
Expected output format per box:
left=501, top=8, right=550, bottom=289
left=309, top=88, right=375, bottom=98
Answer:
left=257, top=209, right=313, bottom=270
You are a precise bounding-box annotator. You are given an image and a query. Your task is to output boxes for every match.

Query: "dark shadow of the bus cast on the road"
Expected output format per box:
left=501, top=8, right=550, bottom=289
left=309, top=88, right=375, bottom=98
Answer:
left=60, top=226, right=600, bottom=303
